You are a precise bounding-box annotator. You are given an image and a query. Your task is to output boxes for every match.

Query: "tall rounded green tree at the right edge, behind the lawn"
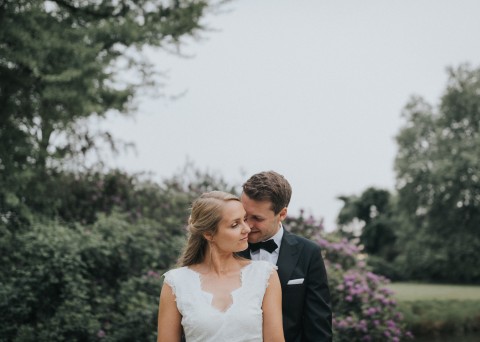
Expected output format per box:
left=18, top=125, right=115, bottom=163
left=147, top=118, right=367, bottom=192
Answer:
left=395, top=65, right=480, bottom=282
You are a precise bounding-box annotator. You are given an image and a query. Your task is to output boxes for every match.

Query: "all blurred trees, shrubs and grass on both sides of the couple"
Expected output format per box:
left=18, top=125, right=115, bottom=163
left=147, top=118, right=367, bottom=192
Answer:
left=0, top=0, right=480, bottom=341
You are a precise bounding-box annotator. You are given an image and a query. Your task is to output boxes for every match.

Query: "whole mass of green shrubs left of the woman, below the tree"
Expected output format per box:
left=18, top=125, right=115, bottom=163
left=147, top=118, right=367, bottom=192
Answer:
left=0, top=166, right=233, bottom=342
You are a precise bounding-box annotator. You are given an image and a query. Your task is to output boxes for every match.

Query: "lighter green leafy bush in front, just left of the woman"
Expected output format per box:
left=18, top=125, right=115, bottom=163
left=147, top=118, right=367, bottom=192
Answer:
left=0, top=214, right=183, bottom=341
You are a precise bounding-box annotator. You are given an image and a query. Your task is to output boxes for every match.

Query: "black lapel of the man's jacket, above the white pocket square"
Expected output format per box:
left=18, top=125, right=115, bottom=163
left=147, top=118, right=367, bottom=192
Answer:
left=277, top=230, right=301, bottom=288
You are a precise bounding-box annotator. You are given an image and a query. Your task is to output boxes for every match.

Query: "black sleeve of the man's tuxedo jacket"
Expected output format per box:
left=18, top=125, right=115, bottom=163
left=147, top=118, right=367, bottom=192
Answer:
left=302, top=245, right=332, bottom=342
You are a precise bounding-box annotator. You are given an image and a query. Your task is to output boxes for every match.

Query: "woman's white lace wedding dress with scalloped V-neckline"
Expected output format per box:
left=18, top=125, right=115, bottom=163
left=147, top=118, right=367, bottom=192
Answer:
left=164, top=261, right=277, bottom=342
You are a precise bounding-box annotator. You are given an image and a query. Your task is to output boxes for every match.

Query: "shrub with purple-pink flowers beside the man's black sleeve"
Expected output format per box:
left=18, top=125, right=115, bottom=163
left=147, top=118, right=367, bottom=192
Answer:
left=286, top=212, right=413, bottom=342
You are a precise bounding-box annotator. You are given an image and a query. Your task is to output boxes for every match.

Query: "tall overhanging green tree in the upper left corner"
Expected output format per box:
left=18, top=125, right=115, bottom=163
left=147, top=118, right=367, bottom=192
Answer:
left=0, top=0, right=219, bottom=216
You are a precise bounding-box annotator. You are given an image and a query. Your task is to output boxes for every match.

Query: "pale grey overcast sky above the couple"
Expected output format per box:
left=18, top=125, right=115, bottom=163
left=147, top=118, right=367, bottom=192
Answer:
left=100, top=0, right=480, bottom=230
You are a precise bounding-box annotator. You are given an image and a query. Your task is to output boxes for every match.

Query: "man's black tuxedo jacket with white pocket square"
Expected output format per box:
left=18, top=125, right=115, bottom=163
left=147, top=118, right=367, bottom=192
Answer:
left=240, top=230, right=332, bottom=342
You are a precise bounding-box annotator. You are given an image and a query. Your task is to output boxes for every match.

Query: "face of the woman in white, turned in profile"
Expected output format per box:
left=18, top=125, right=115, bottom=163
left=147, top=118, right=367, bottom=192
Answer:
left=213, top=201, right=250, bottom=252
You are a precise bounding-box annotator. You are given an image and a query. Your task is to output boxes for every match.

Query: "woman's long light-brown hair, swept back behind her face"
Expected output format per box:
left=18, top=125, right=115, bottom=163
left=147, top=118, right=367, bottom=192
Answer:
left=178, top=191, right=240, bottom=266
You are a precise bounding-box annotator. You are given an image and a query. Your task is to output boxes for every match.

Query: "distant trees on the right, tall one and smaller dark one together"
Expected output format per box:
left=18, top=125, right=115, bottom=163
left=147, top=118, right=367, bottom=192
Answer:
left=338, top=65, right=480, bottom=284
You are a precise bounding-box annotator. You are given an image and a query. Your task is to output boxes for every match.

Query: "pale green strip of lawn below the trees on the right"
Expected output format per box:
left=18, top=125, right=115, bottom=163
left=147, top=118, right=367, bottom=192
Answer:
left=387, top=283, right=480, bottom=302
